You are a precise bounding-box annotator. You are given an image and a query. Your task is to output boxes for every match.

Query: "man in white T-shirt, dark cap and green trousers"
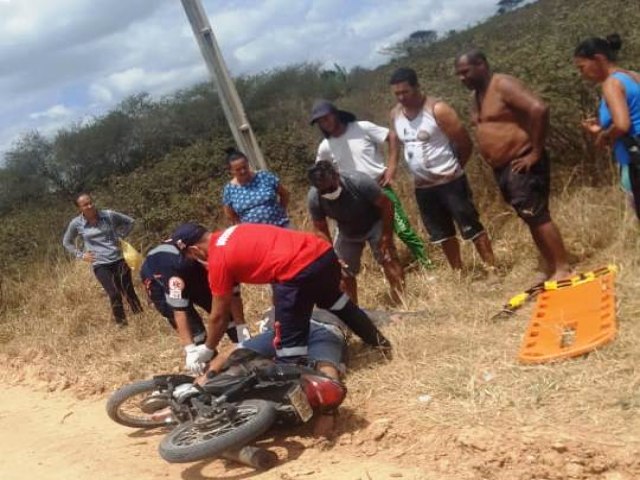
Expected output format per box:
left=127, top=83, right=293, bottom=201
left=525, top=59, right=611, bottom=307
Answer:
left=311, top=100, right=432, bottom=266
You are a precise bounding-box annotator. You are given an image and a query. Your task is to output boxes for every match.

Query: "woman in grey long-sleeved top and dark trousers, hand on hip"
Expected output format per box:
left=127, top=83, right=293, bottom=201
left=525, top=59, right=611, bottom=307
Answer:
left=62, top=193, right=142, bottom=327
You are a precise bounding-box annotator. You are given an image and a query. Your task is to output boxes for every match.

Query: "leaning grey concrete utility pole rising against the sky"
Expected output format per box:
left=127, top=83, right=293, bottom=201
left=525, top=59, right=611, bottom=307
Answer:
left=181, top=0, right=267, bottom=170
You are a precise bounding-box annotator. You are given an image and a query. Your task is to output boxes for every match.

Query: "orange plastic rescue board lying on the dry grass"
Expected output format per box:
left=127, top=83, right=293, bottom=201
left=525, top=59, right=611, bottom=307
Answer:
left=518, top=267, right=617, bottom=363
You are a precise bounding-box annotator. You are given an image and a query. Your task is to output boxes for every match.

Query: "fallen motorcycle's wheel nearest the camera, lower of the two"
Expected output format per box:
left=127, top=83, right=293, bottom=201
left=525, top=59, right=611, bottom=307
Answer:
left=158, top=400, right=276, bottom=463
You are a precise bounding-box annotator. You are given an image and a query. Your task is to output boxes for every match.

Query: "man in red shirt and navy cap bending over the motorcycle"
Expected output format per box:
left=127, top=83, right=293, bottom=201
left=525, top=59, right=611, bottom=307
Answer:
left=171, top=223, right=391, bottom=362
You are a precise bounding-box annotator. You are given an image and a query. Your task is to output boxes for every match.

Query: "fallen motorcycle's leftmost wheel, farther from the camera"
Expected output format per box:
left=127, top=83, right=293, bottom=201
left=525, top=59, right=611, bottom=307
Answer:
left=107, top=380, right=179, bottom=428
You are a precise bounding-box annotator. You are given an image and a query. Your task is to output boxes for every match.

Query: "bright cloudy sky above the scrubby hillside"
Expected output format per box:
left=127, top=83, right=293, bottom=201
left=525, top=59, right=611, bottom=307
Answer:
left=0, top=0, right=510, bottom=158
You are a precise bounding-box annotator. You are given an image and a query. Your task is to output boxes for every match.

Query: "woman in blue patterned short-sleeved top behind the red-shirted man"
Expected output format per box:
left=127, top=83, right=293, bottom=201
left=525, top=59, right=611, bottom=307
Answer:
left=222, top=149, right=290, bottom=228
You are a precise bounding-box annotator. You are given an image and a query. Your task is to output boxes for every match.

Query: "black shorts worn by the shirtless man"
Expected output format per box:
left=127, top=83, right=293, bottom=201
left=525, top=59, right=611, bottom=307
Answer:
left=493, top=152, right=551, bottom=227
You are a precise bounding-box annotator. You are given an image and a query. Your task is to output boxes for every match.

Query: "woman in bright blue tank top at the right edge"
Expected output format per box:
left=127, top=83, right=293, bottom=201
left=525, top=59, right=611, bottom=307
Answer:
left=574, top=34, right=640, bottom=218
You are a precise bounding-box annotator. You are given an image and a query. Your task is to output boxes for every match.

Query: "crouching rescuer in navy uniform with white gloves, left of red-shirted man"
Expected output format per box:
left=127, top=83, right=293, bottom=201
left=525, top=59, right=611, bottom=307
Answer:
left=140, top=242, right=249, bottom=374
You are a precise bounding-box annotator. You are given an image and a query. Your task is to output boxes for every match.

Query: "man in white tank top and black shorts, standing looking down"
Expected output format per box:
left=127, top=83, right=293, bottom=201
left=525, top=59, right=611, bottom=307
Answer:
left=389, top=68, right=495, bottom=271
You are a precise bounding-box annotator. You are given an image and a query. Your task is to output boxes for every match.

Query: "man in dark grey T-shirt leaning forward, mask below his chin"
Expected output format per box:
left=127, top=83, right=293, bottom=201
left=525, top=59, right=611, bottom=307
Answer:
left=308, top=160, right=404, bottom=304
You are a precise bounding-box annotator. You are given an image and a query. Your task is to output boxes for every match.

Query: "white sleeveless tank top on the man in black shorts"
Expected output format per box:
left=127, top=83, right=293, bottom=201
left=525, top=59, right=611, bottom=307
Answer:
left=393, top=110, right=464, bottom=188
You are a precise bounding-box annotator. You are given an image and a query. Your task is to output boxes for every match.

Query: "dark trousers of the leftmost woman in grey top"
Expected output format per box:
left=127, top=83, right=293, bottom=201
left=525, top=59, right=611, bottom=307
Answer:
left=93, top=260, right=142, bottom=323
